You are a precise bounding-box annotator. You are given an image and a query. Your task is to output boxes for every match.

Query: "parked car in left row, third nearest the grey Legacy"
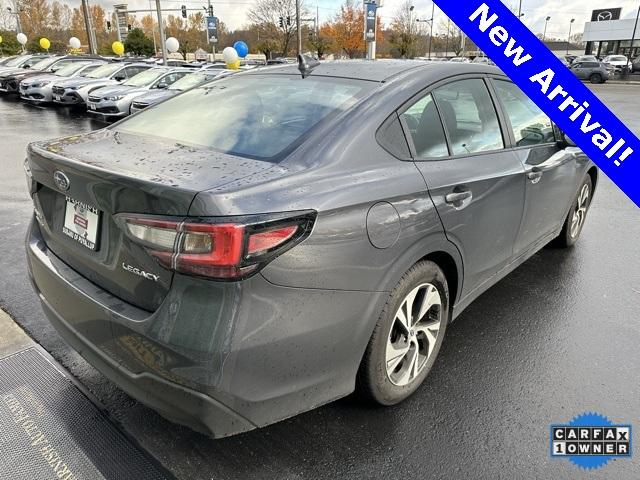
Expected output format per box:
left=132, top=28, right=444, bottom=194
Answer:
left=52, top=63, right=153, bottom=107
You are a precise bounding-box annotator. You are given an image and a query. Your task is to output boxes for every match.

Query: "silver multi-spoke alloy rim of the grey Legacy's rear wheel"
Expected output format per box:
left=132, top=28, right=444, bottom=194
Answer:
left=385, top=283, right=442, bottom=386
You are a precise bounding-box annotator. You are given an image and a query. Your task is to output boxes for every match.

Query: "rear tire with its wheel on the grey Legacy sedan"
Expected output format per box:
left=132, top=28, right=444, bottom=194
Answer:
left=356, top=261, right=450, bottom=405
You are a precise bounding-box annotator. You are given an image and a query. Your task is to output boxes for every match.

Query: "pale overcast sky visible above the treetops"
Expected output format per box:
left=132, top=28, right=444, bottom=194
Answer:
left=79, top=0, right=638, bottom=34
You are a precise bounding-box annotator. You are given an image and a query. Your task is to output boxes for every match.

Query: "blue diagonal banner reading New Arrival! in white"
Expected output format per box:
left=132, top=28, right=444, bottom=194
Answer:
left=435, top=0, right=640, bottom=206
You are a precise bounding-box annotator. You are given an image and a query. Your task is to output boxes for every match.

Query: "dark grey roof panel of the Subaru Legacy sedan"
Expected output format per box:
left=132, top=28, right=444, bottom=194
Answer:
left=248, top=59, right=501, bottom=83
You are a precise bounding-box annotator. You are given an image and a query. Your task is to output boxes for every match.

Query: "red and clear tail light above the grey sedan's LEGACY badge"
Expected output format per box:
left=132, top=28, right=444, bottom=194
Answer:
left=116, top=212, right=315, bottom=280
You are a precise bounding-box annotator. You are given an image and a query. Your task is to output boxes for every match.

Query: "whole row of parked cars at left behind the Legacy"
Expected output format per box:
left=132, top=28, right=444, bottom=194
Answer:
left=0, top=55, right=255, bottom=119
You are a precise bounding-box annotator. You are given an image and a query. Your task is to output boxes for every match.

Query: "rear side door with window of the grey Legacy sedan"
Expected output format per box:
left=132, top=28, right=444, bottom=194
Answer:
left=399, top=77, right=525, bottom=296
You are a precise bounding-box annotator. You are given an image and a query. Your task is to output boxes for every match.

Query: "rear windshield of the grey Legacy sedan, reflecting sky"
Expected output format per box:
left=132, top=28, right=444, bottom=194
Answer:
left=114, top=74, right=377, bottom=159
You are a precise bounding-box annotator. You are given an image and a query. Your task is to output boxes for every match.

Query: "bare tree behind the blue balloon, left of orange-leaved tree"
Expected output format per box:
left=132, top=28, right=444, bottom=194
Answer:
left=248, top=0, right=306, bottom=56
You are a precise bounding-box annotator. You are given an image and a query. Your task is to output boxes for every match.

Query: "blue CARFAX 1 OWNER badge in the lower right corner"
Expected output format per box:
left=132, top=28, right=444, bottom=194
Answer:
left=550, top=413, right=632, bottom=469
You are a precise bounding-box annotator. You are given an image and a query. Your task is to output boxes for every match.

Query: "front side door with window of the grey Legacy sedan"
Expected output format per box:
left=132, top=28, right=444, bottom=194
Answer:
left=491, top=78, right=580, bottom=255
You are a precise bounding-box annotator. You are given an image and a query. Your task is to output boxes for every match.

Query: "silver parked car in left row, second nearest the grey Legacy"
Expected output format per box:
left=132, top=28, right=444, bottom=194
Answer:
left=87, top=67, right=193, bottom=118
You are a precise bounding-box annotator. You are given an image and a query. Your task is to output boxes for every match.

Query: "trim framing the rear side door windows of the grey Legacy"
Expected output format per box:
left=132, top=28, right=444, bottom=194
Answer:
left=396, top=73, right=513, bottom=162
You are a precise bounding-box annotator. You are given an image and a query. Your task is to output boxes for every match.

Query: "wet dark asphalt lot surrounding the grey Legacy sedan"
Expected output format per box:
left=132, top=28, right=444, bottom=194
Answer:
left=0, top=85, right=640, bottom=479
